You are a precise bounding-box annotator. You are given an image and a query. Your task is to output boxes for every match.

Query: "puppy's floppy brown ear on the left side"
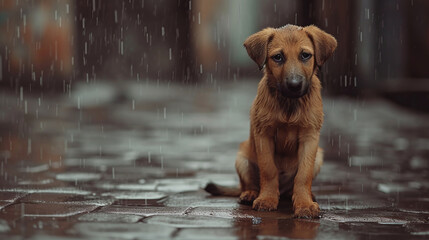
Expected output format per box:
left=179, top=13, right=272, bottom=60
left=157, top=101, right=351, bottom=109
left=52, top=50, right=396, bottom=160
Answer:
left=243, top=28, right=274, bottom=70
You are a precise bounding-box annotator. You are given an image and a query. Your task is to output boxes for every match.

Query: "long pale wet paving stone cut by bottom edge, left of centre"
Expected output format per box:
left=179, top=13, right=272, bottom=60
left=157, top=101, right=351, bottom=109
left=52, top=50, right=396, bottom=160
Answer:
left=68, top=222, right=176, bottom=240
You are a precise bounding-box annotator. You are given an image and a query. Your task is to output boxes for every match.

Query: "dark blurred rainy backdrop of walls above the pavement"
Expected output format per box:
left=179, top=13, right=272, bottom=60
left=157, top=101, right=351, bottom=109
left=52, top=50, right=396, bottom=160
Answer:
left=0, top=0, right=429, bottom=107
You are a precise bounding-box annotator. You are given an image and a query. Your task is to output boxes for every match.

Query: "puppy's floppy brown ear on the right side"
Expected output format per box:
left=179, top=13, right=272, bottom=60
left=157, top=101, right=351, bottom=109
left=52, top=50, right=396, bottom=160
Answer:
left=304, top=25, right=337, bottom=67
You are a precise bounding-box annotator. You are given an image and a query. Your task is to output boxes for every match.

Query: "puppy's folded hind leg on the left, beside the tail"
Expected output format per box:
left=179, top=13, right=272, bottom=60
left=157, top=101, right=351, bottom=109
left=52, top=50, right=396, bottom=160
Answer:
left=235, top=141, right=259, bottom=205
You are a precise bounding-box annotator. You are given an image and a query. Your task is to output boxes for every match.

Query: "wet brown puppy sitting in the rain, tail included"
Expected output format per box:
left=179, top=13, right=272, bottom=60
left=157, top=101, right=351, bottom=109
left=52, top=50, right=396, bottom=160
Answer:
left=205, top=24, right=337, bottom=218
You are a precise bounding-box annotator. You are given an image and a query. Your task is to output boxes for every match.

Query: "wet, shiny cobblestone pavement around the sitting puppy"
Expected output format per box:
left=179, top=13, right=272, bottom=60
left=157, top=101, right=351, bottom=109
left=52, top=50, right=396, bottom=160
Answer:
left=0, top=80, right=429, bottom=239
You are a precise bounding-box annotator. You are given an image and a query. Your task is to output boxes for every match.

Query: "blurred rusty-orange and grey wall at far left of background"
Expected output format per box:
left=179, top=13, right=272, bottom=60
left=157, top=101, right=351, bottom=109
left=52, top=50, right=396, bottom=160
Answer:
left=0, top=0, right=74, bottom=90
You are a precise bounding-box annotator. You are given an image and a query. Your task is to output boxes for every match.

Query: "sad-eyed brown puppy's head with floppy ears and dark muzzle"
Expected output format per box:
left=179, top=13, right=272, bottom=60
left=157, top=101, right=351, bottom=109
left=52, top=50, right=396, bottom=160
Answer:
left=244, top=25, right=337, bottom=98
